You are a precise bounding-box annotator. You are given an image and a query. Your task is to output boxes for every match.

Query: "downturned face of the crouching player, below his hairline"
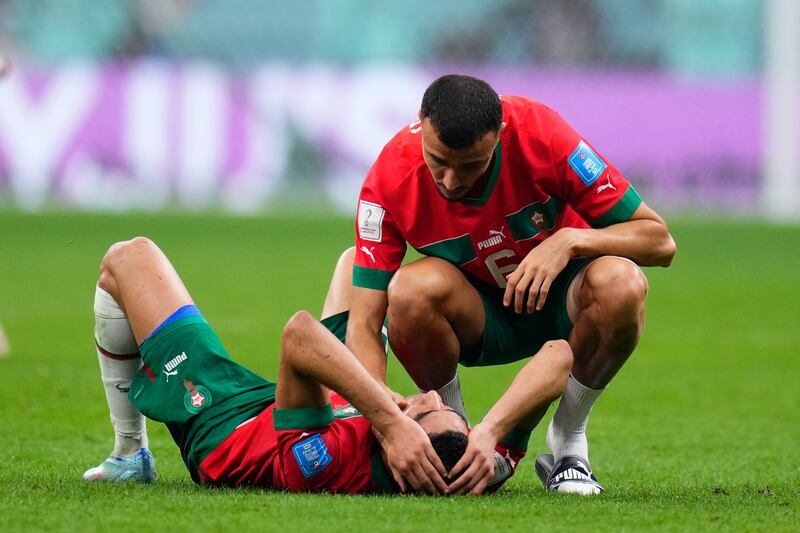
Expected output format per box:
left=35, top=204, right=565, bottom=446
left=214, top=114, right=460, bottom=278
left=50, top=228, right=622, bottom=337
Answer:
left=422, top=118, right=505, bottom=200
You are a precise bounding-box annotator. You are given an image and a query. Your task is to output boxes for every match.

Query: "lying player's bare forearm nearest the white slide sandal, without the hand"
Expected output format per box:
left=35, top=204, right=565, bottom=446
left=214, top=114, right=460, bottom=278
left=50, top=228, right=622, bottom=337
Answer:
left=476, top=341, right=572, bottom=442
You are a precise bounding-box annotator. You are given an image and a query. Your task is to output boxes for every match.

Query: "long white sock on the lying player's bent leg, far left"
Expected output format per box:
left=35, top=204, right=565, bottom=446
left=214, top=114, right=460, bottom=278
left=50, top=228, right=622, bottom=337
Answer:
left=94, top=287, right=148, bottom=455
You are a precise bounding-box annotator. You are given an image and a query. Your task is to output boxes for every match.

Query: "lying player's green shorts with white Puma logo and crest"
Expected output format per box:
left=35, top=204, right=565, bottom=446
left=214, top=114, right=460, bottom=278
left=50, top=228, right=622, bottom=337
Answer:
left=128, top=316, right=275, bottom=482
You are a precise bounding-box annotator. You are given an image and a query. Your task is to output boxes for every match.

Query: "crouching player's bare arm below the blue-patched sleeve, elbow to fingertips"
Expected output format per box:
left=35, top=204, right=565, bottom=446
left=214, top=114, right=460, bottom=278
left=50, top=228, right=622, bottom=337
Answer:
left=503, top=203, right=676, bottom=313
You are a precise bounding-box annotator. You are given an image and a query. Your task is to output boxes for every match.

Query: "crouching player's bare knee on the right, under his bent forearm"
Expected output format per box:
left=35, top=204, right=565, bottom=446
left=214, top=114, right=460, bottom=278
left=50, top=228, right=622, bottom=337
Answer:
left=584, top=257, right=648, bottom=312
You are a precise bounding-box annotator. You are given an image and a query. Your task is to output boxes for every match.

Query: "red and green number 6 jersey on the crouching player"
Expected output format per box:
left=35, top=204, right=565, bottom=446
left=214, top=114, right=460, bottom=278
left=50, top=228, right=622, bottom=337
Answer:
left=353, top=96, right=642, bottom=290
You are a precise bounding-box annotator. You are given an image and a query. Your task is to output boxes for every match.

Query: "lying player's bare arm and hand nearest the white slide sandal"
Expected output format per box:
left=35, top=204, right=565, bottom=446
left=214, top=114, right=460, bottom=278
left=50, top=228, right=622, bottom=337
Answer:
left=450, top=340, right=572, bottom=494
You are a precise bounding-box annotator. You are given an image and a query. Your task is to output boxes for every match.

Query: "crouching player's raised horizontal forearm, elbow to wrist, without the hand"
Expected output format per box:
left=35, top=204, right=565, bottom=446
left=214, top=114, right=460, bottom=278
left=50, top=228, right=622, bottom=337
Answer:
left=556, top=219, right=675, bottom=267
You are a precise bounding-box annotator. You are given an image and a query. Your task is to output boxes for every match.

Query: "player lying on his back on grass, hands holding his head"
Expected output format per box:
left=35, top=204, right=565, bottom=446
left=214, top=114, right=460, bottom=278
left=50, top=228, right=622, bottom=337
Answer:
left=84, top=237, right=572, bottom=494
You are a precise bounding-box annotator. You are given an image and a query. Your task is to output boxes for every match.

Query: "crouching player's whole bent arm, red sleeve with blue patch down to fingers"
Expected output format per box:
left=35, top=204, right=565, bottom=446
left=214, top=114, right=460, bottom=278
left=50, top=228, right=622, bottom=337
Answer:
left=503, top=109, right=675, bottom=313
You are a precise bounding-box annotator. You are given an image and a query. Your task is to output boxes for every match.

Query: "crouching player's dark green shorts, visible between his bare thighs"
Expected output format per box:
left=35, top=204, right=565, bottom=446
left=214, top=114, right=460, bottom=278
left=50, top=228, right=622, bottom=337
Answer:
left=459, top=257, right=594, bottom=366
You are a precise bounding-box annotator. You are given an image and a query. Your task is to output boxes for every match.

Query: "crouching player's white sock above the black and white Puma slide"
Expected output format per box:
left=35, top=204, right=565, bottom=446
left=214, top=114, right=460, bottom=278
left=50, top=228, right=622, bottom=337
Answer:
left=547, top=374, right=604, bottom=462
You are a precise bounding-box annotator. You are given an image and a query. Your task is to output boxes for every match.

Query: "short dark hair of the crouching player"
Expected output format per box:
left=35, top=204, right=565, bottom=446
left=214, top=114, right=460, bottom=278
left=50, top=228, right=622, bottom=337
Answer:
left=420, top=74, right=503, bottom=150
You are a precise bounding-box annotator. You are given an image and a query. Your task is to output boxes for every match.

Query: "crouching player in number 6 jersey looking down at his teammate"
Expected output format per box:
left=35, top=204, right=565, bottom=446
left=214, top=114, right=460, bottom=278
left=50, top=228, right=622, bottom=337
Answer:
left=347, top=75, right=676, bottom=495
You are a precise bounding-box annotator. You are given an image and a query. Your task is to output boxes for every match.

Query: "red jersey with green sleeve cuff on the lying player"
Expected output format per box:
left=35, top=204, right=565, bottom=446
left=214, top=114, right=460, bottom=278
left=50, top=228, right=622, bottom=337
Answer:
left=199, top=393, right=396, bottom=494
